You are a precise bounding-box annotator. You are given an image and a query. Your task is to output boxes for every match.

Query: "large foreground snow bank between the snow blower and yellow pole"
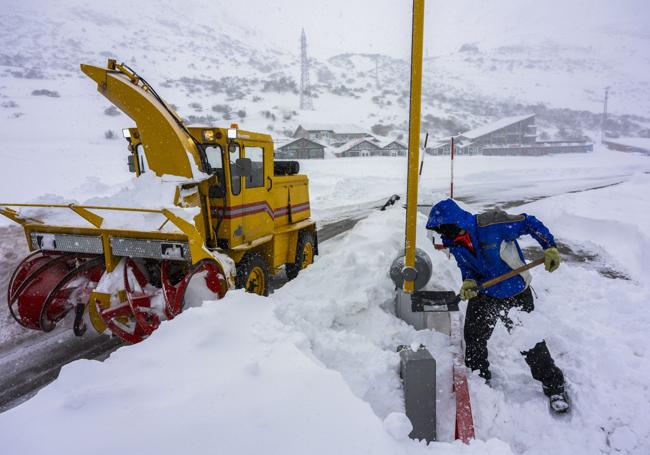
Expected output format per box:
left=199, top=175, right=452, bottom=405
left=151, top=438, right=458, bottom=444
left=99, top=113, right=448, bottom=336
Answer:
left=0, top=208, right=508, bottom=454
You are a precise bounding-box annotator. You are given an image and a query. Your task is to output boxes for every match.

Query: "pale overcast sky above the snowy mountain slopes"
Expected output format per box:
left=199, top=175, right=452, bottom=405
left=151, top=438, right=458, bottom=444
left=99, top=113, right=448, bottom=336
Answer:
left=227, top=0, right=650, bottom=57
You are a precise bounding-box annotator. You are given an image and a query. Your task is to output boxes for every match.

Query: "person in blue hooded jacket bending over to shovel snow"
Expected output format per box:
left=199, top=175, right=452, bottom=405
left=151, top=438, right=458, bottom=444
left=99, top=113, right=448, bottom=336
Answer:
left=427, top=199, right=569, bottom=412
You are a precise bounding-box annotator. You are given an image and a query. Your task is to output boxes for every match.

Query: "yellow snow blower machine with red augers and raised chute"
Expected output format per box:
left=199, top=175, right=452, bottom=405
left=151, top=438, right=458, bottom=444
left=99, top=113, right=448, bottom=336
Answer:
left=0, top=60, right=318, bottom=343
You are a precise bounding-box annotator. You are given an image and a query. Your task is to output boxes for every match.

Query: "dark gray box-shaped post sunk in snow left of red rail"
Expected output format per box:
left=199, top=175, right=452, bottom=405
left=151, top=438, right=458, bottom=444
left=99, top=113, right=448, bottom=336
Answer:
left=398, top=346, right=436, bottom=443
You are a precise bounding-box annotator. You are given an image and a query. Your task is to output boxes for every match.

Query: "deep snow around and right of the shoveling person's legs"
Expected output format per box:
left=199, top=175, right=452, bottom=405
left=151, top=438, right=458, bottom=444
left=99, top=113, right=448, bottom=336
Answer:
left=471, top=174, right=650, bottom=454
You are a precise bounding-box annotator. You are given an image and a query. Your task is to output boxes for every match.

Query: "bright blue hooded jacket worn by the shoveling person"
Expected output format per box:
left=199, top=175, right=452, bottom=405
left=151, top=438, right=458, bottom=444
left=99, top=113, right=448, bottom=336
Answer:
left=427, top=199, right=555, bottom=299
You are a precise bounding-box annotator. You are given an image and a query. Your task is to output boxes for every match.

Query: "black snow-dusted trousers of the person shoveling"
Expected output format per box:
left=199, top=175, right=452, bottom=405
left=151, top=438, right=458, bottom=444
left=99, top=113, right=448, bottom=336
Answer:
left=465, top=288, right=564, bottom=396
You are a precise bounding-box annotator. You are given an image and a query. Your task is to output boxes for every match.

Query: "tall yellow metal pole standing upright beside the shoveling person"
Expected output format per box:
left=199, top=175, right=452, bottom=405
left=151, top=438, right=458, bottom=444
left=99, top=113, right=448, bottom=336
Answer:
left=403, top=0, right=424, bottom=294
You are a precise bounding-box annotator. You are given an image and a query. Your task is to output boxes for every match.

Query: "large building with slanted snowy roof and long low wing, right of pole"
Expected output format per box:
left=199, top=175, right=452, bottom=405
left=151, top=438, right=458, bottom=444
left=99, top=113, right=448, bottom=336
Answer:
left=427, top=114, right=593, bottom=155
